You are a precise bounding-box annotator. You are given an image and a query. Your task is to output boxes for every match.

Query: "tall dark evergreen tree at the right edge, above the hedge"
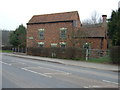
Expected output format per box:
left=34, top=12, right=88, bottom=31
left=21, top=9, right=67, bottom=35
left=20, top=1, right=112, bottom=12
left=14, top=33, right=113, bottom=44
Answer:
left=108, top=8, right=120, bottom=46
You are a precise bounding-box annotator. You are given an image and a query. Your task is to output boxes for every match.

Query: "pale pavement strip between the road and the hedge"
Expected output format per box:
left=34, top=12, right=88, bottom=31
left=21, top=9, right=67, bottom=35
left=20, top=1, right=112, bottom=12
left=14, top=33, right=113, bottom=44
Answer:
left=4, top=53, right=120, bottom=72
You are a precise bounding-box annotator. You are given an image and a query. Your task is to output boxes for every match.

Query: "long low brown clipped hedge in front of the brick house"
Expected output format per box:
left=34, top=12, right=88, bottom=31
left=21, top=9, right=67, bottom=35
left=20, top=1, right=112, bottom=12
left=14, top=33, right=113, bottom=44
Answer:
left=27, top=47, right=84, bottom=59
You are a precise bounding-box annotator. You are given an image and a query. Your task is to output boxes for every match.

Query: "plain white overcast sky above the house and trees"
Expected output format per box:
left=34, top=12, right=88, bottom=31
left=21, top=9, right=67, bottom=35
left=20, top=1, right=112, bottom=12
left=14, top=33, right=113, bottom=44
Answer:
left=0, top=0, right=120, bottom=30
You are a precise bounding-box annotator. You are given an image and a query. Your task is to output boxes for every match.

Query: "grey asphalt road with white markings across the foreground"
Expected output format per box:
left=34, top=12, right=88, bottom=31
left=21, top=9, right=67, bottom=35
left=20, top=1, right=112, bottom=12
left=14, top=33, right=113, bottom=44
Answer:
left=0, top=54, right=118, bottom=88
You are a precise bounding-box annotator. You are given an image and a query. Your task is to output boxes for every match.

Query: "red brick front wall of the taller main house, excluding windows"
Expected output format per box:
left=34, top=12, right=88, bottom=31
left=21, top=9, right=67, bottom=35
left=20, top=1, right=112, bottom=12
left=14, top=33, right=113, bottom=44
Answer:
left=27, top=22, right=73, bottom=47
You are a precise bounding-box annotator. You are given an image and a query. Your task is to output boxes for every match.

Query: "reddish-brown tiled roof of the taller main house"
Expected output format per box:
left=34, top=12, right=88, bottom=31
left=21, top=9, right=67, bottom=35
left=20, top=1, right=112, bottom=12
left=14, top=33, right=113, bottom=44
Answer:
left=28, top=11, right=78, bottom=23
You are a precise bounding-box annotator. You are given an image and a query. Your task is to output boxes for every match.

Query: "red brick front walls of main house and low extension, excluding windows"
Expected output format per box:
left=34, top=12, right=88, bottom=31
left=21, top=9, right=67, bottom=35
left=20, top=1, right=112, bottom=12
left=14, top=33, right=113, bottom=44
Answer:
left=27, top=22, right=107, bottom=50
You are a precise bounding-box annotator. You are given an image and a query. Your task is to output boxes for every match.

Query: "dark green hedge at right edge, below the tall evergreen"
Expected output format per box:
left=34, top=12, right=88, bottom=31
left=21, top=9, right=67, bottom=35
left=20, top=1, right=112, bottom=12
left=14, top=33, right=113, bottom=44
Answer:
left=110, top=46, right=120, bottom=64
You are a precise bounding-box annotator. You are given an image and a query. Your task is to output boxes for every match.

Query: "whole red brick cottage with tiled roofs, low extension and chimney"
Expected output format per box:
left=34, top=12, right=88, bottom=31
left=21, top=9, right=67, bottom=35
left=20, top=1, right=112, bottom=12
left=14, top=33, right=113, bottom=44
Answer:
left=27, top=11, right=107, bottom=55
